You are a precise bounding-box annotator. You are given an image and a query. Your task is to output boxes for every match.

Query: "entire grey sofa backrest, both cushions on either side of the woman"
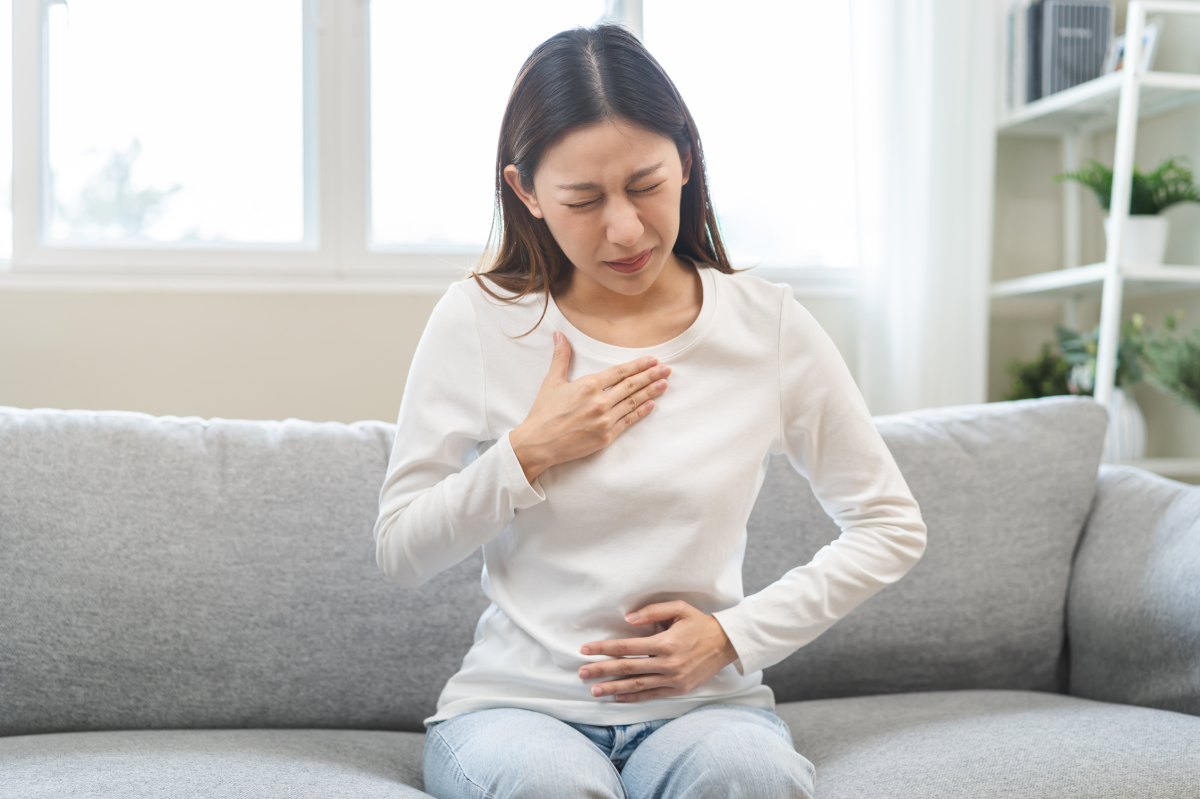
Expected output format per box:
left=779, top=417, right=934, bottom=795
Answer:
left=0, top=398, right=1105, bottom=734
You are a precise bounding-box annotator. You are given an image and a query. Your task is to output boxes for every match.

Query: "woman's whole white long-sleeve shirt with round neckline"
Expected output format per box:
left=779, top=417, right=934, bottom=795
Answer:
left=374, top=257, right=925, bottom=725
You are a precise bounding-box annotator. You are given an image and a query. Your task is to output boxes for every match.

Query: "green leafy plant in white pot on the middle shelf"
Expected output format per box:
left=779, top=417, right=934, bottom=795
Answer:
left=1054, top=156, right=1200, bottom=264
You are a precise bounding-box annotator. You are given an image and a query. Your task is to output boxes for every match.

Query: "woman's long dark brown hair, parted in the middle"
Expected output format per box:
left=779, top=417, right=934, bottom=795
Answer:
left=472, top=25, right=734, bottom=316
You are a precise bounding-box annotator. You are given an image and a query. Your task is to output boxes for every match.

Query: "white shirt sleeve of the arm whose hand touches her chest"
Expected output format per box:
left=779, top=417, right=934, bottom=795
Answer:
left=374, top=283, right=546, bottom=588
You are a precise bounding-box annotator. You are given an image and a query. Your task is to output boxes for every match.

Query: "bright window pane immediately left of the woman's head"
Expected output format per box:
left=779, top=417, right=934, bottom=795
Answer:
left=370, top=0, right=605, bottom=252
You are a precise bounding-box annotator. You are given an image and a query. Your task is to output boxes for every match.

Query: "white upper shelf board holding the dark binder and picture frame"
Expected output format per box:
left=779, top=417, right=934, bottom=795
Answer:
left=996, top=72, right=1200, bottom=137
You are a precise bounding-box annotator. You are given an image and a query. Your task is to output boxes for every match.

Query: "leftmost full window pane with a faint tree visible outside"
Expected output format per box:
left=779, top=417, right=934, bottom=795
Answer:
left=43, top=0, right=316, bottom=246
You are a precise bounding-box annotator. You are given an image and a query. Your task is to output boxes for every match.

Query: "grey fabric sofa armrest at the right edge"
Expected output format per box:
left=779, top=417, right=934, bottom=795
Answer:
left=1067, top=465, right=1200, bottom=715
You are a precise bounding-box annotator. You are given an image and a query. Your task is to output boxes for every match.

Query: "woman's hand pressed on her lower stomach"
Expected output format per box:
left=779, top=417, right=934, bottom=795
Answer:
left=580, top=600, right=738, bottom=702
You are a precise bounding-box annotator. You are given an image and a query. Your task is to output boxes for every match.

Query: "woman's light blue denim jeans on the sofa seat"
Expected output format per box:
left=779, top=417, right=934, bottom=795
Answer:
left=422, top=704, right=814, bottom=799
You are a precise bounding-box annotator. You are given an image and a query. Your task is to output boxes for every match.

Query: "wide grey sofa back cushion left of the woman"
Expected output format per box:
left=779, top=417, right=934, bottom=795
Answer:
left=0, top=408, right=487, bottom=735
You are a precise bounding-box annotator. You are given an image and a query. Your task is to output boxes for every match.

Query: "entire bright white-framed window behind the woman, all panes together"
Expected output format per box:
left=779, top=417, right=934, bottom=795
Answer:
left=0, top=0, right=856, bottom=286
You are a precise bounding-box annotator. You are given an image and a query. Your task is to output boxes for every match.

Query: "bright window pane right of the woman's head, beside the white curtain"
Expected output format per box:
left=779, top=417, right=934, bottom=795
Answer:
left=642, top=0, right=858, bottom=266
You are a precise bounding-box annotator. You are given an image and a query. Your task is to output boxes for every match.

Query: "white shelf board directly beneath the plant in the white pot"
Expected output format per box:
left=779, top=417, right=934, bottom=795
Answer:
left=990, top=264, right=1200, bottom=300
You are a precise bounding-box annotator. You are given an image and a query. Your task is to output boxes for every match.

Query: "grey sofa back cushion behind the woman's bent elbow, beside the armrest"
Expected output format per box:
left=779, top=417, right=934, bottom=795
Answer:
left=744, top=397, right=1108, bottom=702
